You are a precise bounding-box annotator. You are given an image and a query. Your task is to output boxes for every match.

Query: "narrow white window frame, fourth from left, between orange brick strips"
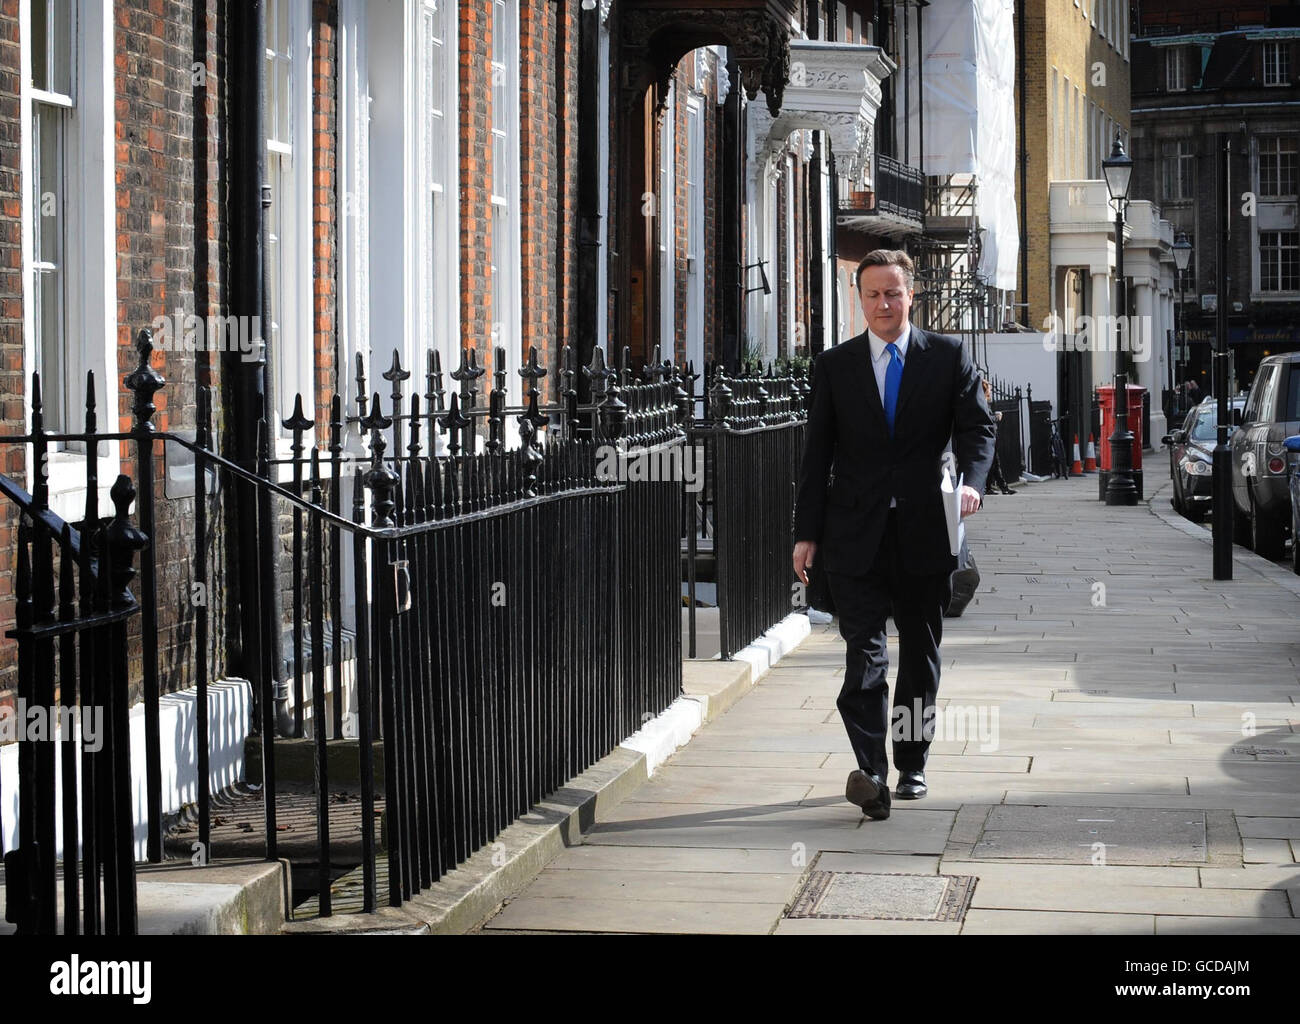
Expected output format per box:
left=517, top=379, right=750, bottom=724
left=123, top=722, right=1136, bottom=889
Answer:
left=489, top=0, right=522, bottom=421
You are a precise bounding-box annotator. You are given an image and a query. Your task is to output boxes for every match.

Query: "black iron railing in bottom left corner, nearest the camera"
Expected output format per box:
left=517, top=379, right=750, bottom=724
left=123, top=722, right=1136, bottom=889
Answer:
left=0, top=374, right=147, bottom=934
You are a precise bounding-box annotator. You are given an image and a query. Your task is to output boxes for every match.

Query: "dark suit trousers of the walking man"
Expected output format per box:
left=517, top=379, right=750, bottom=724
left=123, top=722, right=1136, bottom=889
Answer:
left=826, top=508, right=953, bottom=782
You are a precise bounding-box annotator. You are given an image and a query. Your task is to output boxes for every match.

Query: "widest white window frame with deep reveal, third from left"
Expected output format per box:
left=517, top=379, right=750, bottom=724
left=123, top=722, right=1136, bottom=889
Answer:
left=358, top=0, right=470, bottom=452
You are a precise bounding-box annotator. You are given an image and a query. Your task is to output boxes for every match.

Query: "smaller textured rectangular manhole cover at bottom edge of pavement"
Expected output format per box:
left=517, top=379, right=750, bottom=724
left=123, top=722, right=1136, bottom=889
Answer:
left=787, top=871, right=975, bottom=921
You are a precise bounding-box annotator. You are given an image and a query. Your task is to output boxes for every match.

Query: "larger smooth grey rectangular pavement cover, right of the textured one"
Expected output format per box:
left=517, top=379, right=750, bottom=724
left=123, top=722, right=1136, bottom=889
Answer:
left=974, top=806, right=1208, bottom=864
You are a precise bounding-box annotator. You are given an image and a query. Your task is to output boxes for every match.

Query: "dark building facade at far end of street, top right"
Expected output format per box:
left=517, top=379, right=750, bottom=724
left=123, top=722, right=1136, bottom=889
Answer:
left=1132, top=0, right=1300, bottom=395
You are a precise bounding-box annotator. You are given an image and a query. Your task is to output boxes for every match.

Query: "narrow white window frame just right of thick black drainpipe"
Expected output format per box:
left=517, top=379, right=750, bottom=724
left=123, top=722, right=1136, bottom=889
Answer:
left=263, top=0, right=316, bottom=439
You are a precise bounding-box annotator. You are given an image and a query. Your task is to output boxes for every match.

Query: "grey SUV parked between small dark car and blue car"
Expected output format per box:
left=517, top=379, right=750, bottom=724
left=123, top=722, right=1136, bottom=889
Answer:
left=1229, top=352, right=1300, bottom=560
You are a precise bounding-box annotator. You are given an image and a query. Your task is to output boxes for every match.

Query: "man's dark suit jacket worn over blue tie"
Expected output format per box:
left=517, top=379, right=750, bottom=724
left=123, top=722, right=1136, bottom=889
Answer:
left=794, top=325, right=996, bottom=576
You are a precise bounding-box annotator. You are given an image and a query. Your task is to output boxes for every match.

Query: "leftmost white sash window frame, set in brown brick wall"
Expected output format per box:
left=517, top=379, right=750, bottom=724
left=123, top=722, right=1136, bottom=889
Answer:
left=18, top=0, right=118, bottom=522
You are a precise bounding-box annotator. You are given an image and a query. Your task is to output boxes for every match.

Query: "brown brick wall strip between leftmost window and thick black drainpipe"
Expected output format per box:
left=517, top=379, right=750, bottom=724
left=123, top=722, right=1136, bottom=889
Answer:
left=113, top=0, right=229, bottom=690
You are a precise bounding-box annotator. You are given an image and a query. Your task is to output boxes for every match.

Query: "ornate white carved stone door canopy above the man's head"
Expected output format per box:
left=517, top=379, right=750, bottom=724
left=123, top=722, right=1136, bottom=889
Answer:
left=749, top=39, right=896, bottom=174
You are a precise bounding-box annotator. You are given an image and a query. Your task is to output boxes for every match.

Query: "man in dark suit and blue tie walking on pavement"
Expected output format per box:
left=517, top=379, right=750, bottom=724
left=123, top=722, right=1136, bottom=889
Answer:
left=794, top=250, right=996, bottom=820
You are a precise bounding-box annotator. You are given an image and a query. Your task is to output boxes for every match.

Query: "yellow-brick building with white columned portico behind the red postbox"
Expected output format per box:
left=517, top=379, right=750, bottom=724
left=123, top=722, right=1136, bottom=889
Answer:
left=1017, top=0, right=1174, bottom=446
